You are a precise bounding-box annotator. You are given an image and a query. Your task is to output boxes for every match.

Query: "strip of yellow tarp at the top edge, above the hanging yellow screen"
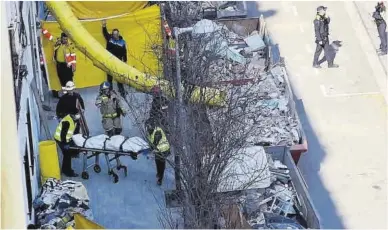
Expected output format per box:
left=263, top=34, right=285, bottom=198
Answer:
left=67, top=1, right=148, bottom=19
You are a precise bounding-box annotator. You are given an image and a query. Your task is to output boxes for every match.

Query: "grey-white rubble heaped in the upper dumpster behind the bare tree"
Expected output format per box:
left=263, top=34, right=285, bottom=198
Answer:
left=192, top=20, right=301, bottom=146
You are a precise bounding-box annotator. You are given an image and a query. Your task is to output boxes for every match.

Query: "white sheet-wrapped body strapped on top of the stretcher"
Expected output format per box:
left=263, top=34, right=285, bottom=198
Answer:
left=73, top=134, right=149, bottom=152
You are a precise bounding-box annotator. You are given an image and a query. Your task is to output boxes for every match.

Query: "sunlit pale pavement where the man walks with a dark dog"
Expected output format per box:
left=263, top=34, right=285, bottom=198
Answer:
left=257, top=1, right=388, bottom=228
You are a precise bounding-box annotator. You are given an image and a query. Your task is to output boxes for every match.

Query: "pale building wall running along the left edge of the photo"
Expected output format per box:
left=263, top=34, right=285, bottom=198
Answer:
left=1, top=1, right=43, bottom=228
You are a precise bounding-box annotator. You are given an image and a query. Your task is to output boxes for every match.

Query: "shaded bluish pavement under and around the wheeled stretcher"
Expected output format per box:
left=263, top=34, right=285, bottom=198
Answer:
left=45, top=87, right=174, bottom=229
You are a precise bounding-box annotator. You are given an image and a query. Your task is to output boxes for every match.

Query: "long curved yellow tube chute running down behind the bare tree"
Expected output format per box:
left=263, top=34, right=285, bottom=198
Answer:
left=46, top=1, right=224, bottom=106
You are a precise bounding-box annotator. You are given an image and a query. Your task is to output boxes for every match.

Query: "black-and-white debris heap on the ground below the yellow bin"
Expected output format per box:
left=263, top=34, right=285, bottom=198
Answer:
left=33, top=178, right=93, bottom=229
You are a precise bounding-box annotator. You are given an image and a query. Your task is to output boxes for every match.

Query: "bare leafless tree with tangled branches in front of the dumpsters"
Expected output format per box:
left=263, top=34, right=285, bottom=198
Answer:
left=118, top=2, right=276, bottom=228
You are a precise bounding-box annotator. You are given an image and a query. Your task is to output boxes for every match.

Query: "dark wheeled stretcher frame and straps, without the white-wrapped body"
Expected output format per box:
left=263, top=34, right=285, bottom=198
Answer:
left=69, top=137, right=149, bottom=183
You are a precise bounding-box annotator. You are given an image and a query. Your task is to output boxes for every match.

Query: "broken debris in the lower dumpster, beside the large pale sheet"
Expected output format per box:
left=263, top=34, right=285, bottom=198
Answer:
left=218, top=149, right=307, bottom=229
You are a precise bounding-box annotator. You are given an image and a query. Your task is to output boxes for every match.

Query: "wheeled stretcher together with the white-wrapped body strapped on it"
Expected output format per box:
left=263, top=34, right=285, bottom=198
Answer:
left=70, top=134, right=149, bottom=183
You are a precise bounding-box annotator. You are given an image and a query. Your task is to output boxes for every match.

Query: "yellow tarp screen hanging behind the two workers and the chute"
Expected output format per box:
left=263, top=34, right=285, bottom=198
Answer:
left=42, top=6, right=163, bottom=90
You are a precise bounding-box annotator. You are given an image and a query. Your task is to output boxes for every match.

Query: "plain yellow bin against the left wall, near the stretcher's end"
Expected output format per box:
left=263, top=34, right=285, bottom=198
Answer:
left=39, top=140, right=61, bottom=184
